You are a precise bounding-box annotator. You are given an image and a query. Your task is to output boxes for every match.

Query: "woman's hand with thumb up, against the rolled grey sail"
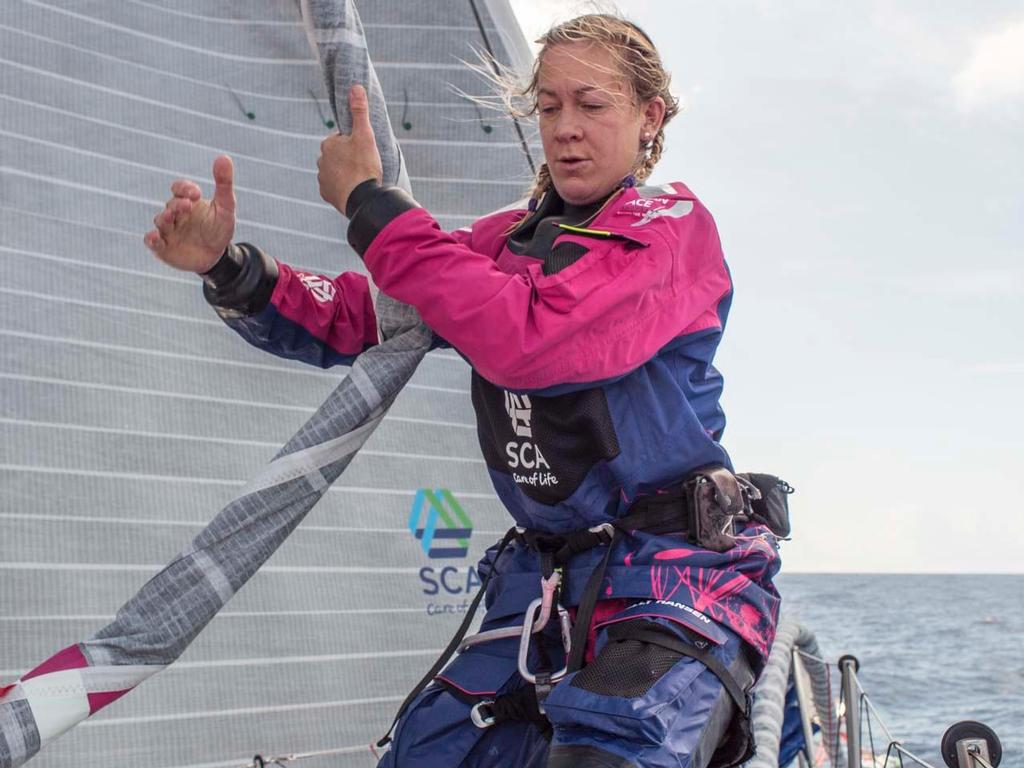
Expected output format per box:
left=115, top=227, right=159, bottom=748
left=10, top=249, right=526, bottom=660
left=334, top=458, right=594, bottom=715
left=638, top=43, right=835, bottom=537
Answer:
left=316, top=85, right=384, bottom=215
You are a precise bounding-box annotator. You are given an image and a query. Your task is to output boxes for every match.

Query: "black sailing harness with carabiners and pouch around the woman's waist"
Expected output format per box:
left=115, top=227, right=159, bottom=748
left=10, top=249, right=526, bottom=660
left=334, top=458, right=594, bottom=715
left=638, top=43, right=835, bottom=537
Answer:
left=376, top=467, right=793, bottom=749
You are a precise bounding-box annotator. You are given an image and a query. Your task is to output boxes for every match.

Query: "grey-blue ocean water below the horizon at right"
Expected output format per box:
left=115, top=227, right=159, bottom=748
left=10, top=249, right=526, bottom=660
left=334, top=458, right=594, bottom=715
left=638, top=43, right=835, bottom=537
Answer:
left=776, top=572, right=1024, bottom=768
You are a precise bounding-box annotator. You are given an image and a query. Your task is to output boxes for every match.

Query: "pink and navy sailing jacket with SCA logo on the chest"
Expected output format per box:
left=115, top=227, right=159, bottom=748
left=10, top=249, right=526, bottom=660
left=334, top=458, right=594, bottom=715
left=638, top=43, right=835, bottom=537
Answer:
left=207, top=182, right=778, bottom=652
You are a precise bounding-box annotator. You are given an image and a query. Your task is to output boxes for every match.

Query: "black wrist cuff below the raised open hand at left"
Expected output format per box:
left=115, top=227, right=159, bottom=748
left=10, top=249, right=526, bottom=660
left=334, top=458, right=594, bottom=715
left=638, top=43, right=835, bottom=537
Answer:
left=203, top=243, right=278, bottom=317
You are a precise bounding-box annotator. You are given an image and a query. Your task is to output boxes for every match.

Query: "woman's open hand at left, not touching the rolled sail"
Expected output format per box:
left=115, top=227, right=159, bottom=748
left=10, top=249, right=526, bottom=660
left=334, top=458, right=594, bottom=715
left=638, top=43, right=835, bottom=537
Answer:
left=143, top=155, right=234, bottom=272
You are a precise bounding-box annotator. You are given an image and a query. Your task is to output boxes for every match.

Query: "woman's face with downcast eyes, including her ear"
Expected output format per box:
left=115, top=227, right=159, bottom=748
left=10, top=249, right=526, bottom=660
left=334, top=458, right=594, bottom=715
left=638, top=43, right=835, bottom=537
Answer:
left=537, top=43, right=665, bottom=205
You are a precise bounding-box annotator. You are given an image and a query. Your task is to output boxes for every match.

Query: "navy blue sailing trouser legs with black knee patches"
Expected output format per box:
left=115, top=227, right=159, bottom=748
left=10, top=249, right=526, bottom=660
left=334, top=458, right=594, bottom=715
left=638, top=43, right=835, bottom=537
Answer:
left=379, top=623, right=753, bottom=768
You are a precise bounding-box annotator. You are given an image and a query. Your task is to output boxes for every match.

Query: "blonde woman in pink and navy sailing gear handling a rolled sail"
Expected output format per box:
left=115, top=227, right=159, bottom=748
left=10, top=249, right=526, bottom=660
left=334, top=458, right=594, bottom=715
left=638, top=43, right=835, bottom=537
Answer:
left=145, top=14, right=778, bottom=768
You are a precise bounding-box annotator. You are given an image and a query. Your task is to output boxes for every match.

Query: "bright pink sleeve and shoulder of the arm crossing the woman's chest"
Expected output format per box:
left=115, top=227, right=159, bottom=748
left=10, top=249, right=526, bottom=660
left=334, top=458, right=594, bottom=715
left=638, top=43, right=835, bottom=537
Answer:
left=364, top=202, right=731, bottom=390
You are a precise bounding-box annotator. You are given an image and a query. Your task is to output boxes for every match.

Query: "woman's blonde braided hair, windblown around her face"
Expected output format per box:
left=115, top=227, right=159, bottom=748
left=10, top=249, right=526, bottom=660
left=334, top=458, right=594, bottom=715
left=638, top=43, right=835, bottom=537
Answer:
left=524, top=13, right=679, bottom=205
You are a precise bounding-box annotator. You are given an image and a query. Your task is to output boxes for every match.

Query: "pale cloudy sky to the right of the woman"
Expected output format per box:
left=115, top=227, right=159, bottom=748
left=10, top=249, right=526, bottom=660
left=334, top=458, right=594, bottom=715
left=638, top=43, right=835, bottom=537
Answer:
left=511, top=0, right=1024, bottom=573
